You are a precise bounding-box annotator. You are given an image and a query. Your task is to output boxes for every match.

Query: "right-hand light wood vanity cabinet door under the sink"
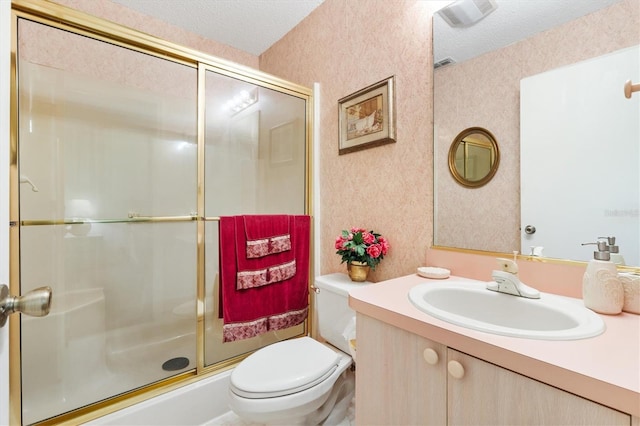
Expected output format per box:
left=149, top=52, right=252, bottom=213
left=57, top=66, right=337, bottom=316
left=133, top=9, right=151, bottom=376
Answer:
left=447, top=349, right=631, bottom=426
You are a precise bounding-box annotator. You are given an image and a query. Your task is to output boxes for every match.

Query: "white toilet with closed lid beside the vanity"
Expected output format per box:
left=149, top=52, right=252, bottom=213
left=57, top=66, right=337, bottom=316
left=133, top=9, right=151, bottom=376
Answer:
left=229, top=274, right=367, bottom=425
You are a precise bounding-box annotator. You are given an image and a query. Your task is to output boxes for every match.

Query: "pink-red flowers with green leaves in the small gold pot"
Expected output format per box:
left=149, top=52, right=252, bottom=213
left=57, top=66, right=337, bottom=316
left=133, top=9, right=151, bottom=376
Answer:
left=335, top=228, right=389, bottom=270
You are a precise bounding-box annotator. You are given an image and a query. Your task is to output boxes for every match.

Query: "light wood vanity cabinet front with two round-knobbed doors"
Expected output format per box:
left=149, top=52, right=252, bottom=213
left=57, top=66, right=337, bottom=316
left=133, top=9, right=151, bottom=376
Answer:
left=356, top=314, right=631, bottom=426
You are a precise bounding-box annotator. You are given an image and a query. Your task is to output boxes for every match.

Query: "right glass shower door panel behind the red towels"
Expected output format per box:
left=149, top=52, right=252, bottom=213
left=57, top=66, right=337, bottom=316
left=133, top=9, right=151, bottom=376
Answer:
left=204, top=70, right=308, bottom=365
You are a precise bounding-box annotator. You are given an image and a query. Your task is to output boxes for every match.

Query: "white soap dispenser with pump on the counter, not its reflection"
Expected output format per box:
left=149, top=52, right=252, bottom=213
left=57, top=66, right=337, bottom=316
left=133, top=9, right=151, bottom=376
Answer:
left=582, top=240, right=624, bottom=315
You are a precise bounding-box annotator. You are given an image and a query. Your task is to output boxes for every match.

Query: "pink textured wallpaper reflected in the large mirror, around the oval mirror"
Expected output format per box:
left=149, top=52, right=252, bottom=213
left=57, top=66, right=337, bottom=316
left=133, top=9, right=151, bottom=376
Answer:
left=434, top=0, right=640, bottom=254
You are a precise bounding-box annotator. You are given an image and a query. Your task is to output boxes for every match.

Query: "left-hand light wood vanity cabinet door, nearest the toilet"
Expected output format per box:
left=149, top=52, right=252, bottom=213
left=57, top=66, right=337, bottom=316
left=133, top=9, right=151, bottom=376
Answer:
left=356, top=314, right=447, bottom=426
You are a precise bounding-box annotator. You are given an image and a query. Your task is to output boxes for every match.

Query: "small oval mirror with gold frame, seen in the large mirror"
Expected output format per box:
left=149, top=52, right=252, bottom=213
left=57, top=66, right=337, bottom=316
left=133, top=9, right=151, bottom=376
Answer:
left=449, top=127, right=500, bottom=188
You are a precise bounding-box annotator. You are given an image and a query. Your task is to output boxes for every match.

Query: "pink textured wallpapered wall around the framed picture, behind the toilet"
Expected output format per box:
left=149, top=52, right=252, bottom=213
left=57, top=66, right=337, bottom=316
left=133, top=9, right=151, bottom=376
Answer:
left=260, top=0, right=440, bottom=281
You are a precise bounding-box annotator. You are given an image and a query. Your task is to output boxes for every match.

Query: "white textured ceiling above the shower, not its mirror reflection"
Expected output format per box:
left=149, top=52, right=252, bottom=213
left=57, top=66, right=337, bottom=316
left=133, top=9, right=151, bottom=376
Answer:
left=111, top=0, right=324, bottom=56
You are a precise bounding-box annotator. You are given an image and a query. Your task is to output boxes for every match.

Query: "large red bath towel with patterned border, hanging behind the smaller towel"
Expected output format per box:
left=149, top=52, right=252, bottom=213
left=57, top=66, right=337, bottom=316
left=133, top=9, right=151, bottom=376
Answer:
left=220, top=215, right=311, bottom=342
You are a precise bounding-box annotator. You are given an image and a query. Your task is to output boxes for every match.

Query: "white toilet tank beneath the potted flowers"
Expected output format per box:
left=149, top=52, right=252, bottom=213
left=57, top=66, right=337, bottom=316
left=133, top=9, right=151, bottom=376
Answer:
left=315, top=274, right=371, bottom=354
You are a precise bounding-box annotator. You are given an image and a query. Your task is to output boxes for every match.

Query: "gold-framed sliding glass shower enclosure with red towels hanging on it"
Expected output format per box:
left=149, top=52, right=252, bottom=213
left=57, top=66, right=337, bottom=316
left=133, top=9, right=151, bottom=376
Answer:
left=10, top=1, right=311, bottom=424
